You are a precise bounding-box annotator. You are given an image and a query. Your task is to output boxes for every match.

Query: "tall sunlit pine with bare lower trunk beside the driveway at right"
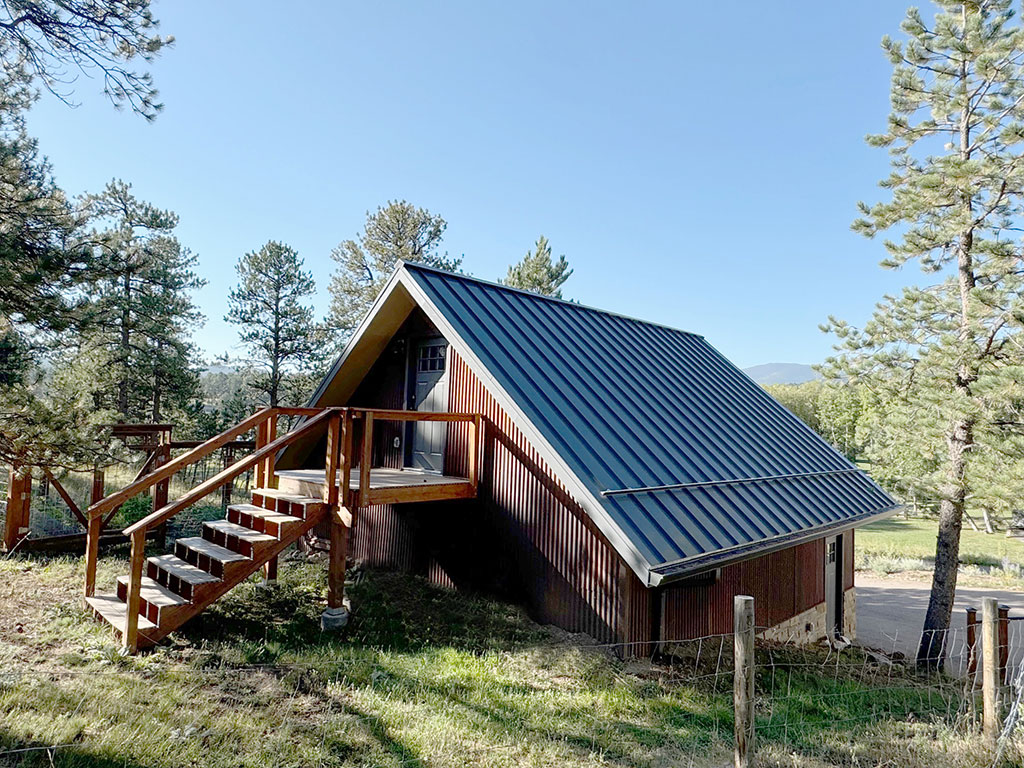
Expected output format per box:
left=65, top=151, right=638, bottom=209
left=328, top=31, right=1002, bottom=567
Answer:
left=826, top=0, right=1024, bottom=668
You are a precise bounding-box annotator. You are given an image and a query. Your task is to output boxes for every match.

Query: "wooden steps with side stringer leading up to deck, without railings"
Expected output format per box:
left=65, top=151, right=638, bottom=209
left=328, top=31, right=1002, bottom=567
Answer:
left=86, top=488, right=328, bottom=647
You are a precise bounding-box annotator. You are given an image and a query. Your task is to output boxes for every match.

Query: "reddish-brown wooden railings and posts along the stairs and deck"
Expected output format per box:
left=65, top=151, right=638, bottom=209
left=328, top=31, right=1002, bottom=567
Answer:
left=85, top=408, right=482, bottom=652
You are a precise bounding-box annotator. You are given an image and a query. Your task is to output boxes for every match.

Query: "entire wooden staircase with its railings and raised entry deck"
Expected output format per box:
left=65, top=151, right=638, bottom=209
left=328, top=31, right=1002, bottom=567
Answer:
left=84, top=407, right=482, bottom=653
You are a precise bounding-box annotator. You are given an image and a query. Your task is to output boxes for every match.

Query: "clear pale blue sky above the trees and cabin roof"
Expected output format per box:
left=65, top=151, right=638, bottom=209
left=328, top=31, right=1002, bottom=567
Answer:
left=30, top=0, right=918, bottom=367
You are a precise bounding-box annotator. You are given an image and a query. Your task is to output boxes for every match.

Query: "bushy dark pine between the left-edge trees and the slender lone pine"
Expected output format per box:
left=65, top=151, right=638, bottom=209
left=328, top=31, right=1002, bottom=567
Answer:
left=75, top=181, right=204, bottom=421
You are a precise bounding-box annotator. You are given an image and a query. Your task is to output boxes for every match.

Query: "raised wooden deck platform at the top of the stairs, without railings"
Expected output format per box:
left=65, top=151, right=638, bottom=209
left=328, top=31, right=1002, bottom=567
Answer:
left=274, top=467, right=476, bottom=507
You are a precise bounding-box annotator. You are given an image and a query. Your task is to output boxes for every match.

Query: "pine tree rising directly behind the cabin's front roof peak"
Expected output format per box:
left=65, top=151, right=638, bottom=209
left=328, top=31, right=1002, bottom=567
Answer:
left=327, top=201, right=462, bottom=344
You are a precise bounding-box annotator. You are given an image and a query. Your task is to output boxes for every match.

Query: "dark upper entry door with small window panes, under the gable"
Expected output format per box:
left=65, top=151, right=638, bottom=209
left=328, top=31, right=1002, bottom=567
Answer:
left=410, top=339, right=447, bottom=472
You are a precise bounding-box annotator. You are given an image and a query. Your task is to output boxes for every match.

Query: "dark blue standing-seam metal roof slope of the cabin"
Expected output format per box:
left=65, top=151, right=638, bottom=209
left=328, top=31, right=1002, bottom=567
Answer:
left=402, top=263, right=897, bottom=568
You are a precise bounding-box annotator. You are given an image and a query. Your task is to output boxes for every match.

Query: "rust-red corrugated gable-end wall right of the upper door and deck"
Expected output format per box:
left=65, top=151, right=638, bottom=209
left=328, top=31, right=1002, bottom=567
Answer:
left=445, top=351, right=650, bottom=642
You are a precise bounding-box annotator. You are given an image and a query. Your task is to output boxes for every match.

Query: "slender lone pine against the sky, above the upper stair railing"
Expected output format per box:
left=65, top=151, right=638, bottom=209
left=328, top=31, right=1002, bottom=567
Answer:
left=224, top=241, right=322, bottom=408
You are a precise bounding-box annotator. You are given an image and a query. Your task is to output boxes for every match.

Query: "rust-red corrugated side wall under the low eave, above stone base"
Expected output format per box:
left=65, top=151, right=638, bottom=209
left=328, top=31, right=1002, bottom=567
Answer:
left=660, top=540, right=825, bottom=642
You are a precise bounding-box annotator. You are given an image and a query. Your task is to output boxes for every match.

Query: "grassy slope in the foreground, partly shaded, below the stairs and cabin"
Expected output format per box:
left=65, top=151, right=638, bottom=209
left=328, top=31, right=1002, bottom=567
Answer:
left=0, top=558, right=1011, bottom=768
